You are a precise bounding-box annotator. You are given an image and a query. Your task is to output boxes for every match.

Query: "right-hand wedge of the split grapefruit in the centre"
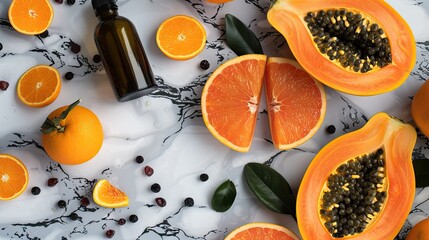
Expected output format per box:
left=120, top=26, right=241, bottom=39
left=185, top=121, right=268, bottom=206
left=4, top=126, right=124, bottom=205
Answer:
left=265, top=58, right=326, bottom=149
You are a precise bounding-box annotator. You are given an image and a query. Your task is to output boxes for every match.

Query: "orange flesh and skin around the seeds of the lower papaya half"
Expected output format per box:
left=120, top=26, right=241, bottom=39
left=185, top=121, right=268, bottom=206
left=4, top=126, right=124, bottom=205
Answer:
left=296, top=112, right=417, bottom=240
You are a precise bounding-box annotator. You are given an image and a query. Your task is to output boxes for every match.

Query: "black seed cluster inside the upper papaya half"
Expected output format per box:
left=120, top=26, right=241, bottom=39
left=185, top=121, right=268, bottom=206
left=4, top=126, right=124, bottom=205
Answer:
left=304, top=9, right=392, bottom=73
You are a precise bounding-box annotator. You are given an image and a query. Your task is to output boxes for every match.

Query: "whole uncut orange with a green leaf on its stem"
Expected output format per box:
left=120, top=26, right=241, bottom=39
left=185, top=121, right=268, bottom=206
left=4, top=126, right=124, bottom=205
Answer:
left=41, top=100, right=104, bottom=165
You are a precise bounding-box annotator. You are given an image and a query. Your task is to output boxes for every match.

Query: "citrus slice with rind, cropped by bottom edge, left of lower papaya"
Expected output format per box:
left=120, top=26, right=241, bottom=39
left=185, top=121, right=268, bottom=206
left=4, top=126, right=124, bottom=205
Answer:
left=225, top=222, right=299, bottom=240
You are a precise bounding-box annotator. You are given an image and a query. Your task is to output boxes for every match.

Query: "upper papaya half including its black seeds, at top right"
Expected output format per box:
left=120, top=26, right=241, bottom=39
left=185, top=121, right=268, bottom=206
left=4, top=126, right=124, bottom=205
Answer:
left=267, top=0, right=416, bottom=96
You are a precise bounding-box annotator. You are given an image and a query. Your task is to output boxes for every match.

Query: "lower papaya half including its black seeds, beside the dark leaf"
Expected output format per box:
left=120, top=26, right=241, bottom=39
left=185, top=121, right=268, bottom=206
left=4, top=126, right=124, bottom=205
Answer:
left=296, top=112, right=417, bottom=240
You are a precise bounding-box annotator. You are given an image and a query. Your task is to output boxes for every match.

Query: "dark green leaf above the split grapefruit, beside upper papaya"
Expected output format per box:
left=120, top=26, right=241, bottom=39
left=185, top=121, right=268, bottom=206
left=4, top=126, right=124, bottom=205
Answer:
left=225, top=14, right=264, bottom=56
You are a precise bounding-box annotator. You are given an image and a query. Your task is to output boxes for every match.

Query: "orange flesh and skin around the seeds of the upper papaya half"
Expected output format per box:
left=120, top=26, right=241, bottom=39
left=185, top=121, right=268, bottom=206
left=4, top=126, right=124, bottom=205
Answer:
left=267, top=0, right=416, bottom=96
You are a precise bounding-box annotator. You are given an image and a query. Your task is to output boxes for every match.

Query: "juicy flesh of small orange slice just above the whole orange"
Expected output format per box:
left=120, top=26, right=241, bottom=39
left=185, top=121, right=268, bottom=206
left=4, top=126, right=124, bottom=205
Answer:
left=19, top=67, right=58, bottom=103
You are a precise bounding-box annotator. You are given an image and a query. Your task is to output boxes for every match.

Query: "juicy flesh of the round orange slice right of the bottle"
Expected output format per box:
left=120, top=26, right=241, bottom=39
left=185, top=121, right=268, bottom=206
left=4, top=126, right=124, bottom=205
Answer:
left=159, top=18, right=205, bottom=55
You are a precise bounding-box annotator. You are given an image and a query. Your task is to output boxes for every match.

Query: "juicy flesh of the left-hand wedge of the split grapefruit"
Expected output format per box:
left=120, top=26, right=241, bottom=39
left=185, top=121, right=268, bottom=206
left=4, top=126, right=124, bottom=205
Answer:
left=206, top=60, right=265, bottom=147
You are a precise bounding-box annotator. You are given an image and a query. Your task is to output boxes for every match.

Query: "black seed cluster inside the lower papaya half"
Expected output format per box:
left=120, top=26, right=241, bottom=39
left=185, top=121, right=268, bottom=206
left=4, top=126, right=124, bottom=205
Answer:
left=320, top=149, right=386, bottom=238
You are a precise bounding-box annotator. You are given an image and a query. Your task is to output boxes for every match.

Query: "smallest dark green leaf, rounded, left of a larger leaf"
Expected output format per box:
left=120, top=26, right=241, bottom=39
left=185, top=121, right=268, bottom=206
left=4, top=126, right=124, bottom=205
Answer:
left=212, top=179, right=237, bottom=212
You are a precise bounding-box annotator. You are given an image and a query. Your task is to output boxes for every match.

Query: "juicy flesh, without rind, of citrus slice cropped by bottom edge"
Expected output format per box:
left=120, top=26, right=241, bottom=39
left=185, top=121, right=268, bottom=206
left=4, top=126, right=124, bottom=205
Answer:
left=231, top=227, right=294, bottom=240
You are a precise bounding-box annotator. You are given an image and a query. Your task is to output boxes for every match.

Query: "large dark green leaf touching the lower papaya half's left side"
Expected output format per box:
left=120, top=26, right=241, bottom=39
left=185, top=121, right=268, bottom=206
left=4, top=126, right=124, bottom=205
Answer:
left=244, top=163, right=296, bottom=219
